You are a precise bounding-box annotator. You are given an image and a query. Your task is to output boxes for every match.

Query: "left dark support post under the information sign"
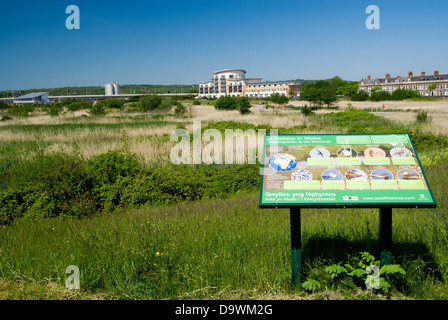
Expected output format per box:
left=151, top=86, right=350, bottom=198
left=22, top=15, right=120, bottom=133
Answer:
left=290, top=208, right=302, bottom=287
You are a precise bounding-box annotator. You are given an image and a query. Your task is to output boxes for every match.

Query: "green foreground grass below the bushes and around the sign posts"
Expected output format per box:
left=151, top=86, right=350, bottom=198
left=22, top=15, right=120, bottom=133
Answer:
left=0, top=160, right=448, bottom=299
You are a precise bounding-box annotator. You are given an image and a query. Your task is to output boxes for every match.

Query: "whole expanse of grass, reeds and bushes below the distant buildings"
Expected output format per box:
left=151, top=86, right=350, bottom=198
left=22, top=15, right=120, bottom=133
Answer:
left=0, top=101, right=448, bottom=299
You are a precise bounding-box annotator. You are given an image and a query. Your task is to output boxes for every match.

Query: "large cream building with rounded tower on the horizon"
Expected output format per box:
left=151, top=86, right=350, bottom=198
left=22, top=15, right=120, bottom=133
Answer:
left=199, top=69, right=302, bottom=98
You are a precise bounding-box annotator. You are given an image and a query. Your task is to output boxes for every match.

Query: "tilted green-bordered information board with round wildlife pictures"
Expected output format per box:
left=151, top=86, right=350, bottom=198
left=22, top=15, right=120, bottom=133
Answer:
left=260, top=133, right=436, bottom=208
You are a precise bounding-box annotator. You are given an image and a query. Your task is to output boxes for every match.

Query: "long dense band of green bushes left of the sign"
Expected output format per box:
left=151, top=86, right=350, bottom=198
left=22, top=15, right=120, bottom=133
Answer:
left=0, top=151, right=259, bottom=224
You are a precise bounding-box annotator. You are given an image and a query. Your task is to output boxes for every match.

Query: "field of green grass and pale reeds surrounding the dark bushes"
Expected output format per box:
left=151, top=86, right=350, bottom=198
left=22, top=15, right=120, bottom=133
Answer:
left=0, top=102, right=448, bottom=299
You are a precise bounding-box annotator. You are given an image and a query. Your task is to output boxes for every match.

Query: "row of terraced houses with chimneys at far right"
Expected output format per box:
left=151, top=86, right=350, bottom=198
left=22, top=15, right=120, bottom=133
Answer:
left=358, top=70, right=448, bottom=97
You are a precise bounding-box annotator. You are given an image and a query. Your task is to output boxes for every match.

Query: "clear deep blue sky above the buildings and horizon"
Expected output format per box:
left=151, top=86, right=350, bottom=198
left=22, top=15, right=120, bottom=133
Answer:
left=0, top=0, right=448, bottom=90
